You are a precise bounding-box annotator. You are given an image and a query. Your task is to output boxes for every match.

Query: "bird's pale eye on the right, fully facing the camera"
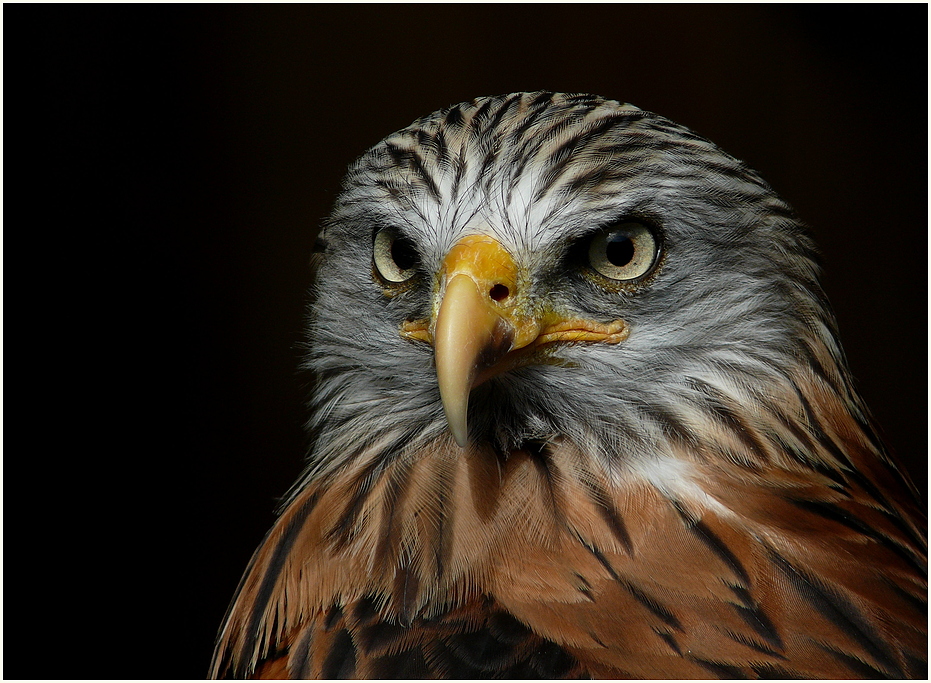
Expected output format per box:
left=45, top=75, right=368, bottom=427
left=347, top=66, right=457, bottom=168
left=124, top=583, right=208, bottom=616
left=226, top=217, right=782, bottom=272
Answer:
left=588, top=221, right=659, bottom=280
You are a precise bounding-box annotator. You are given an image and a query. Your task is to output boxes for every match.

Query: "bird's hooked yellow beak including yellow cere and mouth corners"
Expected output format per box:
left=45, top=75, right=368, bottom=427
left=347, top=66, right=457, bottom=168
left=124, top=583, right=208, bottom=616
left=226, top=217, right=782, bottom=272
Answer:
left=401, top=235, right=629, bottom=447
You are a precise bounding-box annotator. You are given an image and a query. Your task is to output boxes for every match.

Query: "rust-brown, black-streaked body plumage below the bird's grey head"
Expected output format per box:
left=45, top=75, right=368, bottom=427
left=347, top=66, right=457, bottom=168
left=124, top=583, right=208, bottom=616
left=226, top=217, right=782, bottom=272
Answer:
left=214, top=400, right=926, bottom=678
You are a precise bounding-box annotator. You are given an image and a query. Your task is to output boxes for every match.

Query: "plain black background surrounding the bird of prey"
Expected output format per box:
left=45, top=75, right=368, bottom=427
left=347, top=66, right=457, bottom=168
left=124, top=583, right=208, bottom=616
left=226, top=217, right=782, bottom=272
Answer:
left=3, top=5, right=928, bottom=678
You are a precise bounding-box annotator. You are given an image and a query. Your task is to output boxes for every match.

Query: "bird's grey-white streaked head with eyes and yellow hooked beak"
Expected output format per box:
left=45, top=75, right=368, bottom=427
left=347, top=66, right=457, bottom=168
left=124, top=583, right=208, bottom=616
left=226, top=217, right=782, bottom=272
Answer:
left=307, top=93, right=841, bottom=486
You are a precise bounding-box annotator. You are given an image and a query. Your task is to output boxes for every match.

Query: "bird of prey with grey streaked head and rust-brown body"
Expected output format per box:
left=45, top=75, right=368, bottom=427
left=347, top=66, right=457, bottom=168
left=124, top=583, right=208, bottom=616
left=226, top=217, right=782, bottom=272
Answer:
left=211, top=92, right=927, bottom=678
